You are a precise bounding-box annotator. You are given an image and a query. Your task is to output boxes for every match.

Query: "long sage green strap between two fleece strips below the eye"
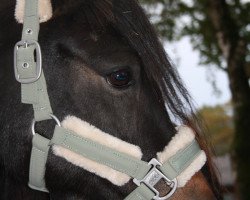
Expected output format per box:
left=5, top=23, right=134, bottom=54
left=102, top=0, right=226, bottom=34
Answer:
left=51, top=126, right=150, bottom=179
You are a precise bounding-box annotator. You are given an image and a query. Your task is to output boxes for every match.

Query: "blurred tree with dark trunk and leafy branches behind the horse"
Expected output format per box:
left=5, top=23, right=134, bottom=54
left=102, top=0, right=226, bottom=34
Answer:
left=141, top=0, right=250, bottom=200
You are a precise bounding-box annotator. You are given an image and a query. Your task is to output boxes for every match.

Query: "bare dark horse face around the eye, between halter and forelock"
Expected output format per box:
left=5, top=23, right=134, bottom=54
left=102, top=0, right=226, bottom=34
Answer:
left=40, top=10, right=175, bottom=153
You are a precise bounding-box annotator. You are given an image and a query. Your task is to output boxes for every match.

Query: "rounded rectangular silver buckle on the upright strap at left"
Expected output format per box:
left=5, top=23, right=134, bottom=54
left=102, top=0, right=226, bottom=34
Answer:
left=14, top=40, right=42, bottom=84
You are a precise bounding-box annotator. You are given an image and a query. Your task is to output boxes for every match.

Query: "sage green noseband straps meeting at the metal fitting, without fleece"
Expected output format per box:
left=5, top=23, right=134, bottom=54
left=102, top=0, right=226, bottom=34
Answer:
left=50, top=126, right=201, bottom=200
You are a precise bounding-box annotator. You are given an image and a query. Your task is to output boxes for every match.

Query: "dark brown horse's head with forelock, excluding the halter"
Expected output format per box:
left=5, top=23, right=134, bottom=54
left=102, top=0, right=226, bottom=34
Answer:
left=0, top=0, right=222, bottom=199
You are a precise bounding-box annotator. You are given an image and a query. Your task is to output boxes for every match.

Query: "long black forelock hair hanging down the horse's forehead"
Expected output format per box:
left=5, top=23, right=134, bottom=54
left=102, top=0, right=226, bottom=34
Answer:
left=54, top=0, right=195, bottom=124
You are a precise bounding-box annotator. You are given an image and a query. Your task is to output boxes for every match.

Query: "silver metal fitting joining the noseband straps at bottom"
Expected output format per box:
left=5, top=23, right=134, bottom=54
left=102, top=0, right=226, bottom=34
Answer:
left=133, top=158, right=177, bottom=200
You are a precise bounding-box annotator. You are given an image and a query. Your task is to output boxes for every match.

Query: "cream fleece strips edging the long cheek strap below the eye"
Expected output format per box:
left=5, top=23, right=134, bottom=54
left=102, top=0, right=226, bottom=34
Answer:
left=53, top=116, right=142, bottom=186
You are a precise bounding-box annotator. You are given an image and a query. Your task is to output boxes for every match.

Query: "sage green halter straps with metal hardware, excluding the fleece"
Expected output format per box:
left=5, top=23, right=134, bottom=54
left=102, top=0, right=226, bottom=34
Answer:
left=14, top=0, right=205, bottom=200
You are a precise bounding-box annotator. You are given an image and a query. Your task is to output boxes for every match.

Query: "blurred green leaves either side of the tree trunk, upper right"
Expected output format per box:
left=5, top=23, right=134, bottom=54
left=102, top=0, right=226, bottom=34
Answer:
left=140, top=0, right=250, bottom=72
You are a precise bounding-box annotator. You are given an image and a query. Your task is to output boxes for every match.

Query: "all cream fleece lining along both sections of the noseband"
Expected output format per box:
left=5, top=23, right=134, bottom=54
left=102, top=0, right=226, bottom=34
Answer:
left=53, top=116, right=206, bottom=187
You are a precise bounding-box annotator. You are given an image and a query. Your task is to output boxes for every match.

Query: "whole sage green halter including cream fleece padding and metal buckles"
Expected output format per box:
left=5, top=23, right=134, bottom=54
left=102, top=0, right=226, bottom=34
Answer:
left=14, top=0, right=206, bottom=200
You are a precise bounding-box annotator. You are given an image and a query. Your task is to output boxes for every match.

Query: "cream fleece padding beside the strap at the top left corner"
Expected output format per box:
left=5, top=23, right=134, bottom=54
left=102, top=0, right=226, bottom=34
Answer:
left=15, top=0, right=52, bottom=23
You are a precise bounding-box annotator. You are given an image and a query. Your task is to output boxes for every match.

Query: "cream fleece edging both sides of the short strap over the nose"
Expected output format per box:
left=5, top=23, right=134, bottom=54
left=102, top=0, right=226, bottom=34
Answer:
left=157, top=126, right=207, bottom=187
